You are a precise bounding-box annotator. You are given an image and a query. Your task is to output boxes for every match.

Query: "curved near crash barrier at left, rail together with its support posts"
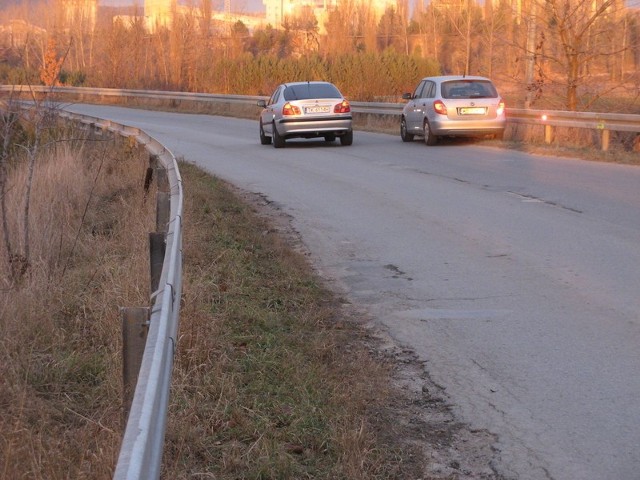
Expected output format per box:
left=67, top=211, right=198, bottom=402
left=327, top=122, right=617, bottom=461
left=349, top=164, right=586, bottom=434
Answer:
left=58, top=110, right=183, bottom=480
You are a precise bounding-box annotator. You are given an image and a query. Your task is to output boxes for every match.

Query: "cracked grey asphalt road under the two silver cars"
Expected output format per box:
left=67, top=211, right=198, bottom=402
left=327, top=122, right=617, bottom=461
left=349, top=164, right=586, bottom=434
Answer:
left=70, top=105, right=640, bottom=480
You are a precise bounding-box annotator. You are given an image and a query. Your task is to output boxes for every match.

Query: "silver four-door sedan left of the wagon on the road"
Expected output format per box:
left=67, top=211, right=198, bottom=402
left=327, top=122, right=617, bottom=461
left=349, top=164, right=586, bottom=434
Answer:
left=258, top=81, right=353, bottom=148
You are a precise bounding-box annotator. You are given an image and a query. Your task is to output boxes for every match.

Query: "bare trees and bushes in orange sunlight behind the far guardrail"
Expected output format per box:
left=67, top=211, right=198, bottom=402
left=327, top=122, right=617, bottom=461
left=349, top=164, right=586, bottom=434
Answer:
left=0, top=0, right=640, bottom=110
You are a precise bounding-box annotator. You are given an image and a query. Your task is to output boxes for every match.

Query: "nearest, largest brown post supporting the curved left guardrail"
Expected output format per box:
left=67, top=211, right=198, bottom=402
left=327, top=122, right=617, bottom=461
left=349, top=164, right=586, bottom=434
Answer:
left=120, top=307, right=151, bottom=424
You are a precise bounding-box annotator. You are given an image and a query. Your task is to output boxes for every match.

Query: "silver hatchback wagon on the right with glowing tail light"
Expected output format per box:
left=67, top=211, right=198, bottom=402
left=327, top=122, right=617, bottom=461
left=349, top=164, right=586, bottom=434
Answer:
left=400, top=75, right=506, bottom=145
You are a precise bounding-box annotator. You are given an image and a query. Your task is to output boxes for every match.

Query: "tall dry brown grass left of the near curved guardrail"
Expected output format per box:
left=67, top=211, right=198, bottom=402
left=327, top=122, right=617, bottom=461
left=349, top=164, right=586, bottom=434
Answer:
left=0, top=123, right=155, bottom=479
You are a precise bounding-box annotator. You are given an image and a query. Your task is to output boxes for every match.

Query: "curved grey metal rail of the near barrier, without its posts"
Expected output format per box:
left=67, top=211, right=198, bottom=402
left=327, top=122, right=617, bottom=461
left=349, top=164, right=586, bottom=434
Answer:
left=59, top=111, right=183, bottom=480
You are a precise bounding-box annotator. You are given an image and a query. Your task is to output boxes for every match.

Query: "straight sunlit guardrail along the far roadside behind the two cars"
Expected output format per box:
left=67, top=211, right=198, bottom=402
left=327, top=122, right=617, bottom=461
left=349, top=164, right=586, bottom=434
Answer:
left=0, top=85, right=640, bottom=150
